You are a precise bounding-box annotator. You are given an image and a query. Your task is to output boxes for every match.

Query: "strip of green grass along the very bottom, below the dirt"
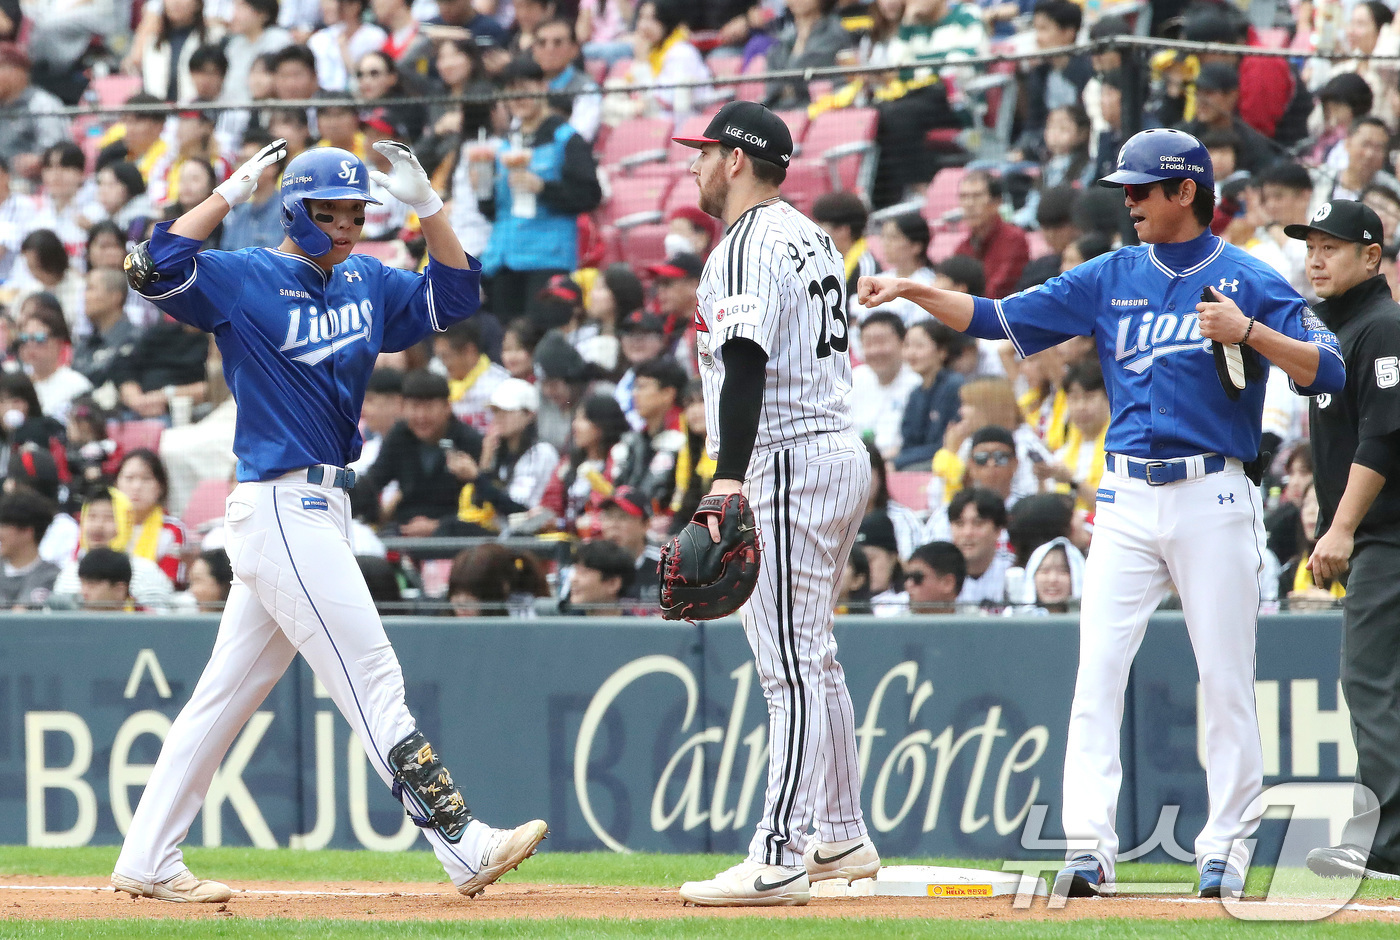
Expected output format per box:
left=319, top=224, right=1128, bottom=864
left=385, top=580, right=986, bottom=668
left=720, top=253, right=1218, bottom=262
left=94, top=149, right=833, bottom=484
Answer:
left=0, top=916, right=1394, bottom=940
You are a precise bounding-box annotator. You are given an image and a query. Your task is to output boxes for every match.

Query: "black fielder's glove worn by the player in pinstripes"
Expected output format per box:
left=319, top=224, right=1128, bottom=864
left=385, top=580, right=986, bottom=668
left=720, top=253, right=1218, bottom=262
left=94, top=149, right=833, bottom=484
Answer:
left=661, top=493, right=759, bottom=621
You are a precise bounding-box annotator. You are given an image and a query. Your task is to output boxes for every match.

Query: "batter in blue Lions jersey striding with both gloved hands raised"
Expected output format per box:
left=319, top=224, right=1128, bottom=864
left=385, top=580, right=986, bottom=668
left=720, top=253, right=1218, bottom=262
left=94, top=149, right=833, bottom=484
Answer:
left=112, top=140, right=546, bottom=902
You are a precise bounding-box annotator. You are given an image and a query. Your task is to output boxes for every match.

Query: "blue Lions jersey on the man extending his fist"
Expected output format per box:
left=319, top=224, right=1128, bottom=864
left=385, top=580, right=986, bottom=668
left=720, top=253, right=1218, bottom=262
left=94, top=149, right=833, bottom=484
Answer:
left=967, top=231, right=1345, bottom=461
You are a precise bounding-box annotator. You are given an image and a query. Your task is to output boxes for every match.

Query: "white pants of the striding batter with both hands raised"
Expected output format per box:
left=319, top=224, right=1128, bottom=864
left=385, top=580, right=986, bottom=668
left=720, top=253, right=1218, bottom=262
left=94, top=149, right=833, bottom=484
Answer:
left=116, top=471, right=490, bottom=884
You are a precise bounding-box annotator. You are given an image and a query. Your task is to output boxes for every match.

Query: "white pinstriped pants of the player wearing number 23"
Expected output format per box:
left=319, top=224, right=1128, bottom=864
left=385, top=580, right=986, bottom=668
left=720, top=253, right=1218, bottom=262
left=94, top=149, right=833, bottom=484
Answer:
left=739, top=434, right=871, bottom=866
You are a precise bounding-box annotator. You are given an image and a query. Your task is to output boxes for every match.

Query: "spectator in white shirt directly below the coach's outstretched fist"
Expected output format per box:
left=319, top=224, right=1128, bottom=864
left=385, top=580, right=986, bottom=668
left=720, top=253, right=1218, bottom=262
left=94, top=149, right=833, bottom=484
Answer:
left=851, top=310, right=921, bottom=459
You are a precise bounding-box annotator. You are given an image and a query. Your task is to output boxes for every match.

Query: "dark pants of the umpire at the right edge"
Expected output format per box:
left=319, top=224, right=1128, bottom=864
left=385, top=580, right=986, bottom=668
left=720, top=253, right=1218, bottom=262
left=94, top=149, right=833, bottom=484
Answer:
left=1341, top=542, right=1400, bottom=873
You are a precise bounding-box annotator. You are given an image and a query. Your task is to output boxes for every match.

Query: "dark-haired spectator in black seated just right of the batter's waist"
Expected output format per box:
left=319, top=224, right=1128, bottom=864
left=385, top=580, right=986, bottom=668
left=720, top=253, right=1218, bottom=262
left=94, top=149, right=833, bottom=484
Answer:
left=351, top=369, right=482, bottom=538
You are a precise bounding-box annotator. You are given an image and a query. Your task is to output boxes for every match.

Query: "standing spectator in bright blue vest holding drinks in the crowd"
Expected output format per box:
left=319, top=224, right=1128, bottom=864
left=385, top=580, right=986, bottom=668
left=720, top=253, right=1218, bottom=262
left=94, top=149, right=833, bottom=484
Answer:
left=482, top=59, right=602, bottom=322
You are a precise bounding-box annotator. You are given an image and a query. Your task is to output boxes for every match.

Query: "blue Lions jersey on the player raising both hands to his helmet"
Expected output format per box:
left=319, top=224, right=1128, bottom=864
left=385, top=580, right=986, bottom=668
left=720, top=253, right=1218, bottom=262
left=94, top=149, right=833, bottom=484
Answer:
left=141, top=223, right=482, bottom=481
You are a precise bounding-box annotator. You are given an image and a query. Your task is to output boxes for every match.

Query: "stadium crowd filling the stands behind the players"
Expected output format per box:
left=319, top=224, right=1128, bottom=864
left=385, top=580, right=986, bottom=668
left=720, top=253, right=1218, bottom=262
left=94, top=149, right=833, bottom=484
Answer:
left=0, top=0, right=1366, bottom=616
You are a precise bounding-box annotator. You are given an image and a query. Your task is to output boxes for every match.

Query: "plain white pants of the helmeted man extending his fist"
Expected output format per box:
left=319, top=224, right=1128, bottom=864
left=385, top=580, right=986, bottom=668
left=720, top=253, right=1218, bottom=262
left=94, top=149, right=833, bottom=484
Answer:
left=1063, top=461, right=1264, bottom=881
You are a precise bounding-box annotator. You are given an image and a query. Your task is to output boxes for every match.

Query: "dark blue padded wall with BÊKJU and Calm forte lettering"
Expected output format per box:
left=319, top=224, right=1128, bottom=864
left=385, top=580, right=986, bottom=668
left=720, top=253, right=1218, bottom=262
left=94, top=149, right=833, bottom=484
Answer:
left=0, top=614, right=1355, bottom=860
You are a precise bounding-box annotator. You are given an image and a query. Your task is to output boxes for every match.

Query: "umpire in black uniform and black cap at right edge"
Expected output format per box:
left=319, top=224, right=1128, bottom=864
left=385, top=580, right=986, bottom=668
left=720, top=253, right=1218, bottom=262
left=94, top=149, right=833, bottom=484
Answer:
left=1284, top=199, right=1400, bottom=880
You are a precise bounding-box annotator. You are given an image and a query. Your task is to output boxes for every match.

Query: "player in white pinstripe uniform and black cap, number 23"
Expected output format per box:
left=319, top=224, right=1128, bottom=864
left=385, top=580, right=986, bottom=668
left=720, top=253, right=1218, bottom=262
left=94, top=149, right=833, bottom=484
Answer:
left=678, top=101, right=879, bottom=906
